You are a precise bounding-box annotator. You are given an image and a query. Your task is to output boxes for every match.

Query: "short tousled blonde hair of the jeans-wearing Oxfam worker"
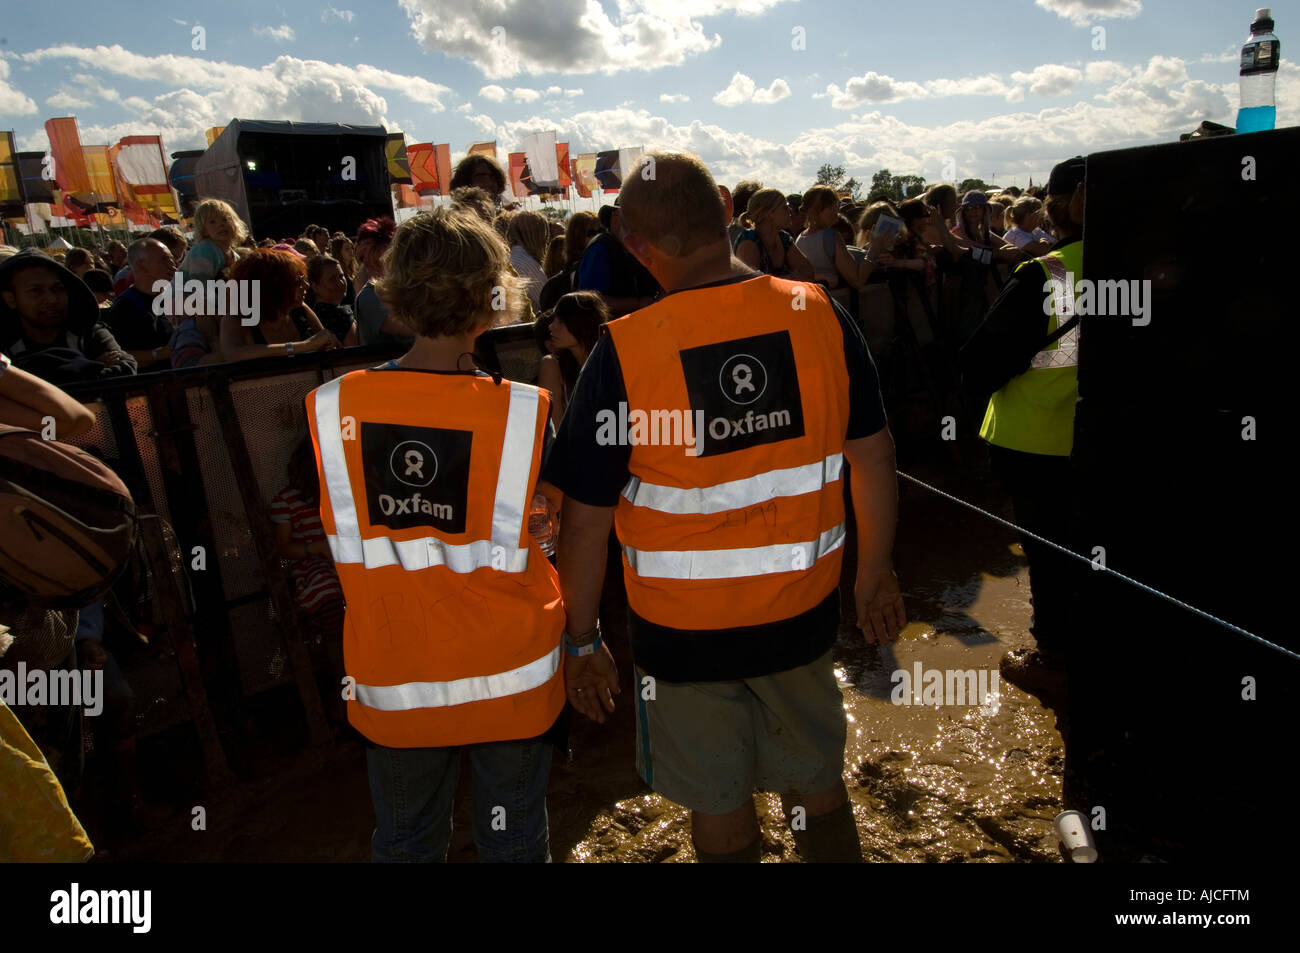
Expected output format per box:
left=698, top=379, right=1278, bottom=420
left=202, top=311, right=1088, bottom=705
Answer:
left=374, top=207, right=524, bottom=338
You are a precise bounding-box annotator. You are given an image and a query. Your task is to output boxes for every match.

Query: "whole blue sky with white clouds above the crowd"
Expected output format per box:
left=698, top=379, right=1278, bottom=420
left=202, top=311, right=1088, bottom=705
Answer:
left=0, top=0, right=1300, bottom=190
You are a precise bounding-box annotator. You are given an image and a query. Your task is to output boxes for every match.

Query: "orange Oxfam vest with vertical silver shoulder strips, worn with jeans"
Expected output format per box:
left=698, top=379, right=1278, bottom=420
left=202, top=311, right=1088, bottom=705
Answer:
left=307, top=369, right=564, bottom=748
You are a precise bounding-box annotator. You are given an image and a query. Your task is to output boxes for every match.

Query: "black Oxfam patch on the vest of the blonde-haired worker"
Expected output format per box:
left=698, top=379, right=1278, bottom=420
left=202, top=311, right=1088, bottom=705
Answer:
left=361, top=420, right=475, bottom=533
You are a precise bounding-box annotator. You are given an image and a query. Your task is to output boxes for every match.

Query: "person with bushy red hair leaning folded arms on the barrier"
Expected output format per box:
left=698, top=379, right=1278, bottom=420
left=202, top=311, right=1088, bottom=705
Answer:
left=221, top=248, right=339, bottom=360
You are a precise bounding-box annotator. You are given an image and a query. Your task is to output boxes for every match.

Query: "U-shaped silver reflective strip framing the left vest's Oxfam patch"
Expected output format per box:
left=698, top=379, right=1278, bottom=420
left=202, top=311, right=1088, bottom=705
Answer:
left=316, top=377, right=540, bottom=573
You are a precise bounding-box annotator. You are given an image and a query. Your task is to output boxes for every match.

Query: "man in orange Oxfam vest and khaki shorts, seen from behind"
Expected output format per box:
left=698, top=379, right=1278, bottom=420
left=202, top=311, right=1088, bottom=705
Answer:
left=545, top=152, right=905, bottom=862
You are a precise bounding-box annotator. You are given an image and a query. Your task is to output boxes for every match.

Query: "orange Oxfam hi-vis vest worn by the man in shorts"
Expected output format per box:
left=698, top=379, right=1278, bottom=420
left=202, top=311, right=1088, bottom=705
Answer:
left=598, top=276, right=849, bottom=629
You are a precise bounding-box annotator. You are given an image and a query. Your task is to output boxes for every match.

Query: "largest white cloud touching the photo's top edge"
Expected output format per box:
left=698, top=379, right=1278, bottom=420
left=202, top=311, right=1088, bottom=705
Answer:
left=400, top=0, right=787, bottom=79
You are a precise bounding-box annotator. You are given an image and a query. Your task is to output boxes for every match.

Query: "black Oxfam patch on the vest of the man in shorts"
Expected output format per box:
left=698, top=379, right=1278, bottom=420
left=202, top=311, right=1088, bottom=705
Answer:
left=680, top=330, right=803, bottom=456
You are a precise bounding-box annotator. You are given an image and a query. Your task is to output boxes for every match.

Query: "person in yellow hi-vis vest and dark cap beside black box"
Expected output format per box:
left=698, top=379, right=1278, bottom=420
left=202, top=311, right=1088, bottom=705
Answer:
left=963, top=156, right=1084, bottom=709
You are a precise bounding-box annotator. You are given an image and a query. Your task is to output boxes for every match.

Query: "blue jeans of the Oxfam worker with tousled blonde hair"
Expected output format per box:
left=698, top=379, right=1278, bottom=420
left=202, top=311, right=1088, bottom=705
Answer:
left=365, top=740, right=551, bottom=863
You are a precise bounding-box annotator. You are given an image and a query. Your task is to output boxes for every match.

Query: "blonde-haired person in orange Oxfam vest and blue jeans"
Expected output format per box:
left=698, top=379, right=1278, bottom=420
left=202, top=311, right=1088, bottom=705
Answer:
left=307, top=209, right=564, bottom=861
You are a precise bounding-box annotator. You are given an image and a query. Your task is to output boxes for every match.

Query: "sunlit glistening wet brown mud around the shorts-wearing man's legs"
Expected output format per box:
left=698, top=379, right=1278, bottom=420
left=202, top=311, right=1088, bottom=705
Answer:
left=569, top=499, right=1062, bottom=862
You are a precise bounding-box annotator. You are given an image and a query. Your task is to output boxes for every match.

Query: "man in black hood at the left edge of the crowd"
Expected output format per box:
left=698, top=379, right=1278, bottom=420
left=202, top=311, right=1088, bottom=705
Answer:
left=0, top=248, right=135, bottom=384
